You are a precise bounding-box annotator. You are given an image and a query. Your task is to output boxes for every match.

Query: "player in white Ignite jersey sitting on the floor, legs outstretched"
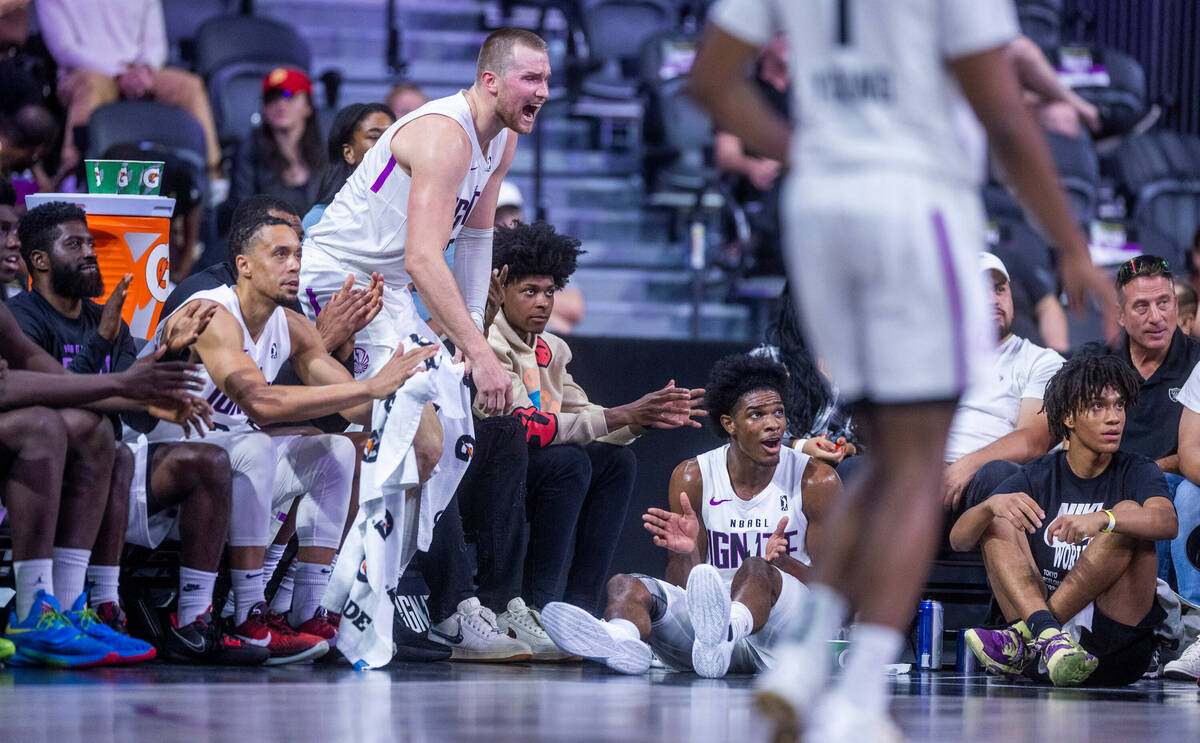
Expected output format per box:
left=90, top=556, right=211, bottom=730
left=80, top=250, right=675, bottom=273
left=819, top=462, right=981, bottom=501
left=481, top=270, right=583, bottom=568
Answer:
left=541, top=355, right=841, bottom=678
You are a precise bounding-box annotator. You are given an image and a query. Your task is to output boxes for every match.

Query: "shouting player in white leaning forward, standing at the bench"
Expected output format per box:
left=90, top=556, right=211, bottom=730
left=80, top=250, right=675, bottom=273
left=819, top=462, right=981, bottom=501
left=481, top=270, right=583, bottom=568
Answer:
left=301, top=29, right=550, bottom=463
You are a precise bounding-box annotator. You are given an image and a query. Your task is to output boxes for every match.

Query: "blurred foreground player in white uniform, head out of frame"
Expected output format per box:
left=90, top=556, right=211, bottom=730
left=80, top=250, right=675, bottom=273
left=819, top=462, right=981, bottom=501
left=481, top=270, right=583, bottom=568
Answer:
left=691, top=0, right=1116, bottom=741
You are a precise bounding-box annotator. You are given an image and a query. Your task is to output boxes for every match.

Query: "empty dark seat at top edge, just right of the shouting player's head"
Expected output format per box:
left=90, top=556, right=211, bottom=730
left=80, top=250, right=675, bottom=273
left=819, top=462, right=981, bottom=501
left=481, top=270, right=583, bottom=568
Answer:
left=582, top=0, right=678, bottom=100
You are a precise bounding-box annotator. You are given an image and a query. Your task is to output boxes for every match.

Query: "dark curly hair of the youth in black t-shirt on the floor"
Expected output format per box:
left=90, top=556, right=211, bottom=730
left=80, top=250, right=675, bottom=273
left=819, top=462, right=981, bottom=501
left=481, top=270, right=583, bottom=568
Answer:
left=1042, top=354, right=1141, bottom=442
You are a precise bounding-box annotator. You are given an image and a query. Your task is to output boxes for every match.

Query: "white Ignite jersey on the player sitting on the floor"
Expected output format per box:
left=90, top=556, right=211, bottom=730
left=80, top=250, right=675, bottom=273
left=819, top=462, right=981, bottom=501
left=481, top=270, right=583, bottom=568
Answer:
left=696, top=444, right=811, bottom=581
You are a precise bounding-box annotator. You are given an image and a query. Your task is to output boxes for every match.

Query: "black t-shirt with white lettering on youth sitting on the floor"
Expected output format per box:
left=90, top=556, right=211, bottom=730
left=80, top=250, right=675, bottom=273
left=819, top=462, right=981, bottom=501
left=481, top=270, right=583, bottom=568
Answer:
left=992, top=451, right=1168, bottom=591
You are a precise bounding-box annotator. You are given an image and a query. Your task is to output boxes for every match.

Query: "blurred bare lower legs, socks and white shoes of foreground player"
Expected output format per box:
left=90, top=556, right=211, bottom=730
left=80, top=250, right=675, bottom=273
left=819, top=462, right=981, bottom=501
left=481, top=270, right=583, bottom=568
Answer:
left=758, top=401, right=954, bottom=741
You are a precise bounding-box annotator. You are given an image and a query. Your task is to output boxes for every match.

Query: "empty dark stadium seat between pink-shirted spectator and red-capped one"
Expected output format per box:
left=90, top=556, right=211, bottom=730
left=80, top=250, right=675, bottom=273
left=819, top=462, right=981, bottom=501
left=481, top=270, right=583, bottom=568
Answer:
left=196, top=16, right=316, bottom=144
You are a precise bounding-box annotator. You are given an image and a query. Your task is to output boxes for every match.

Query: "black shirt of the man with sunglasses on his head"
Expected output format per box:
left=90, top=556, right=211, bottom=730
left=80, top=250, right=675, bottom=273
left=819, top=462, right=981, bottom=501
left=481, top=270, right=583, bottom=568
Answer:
left=1080, top=328, right=1200, bottom=460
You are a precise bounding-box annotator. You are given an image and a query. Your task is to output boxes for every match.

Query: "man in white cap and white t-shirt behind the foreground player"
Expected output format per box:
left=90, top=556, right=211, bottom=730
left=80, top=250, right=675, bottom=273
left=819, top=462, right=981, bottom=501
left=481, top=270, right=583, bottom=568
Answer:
left=943, top=253, right=1063, bottom=511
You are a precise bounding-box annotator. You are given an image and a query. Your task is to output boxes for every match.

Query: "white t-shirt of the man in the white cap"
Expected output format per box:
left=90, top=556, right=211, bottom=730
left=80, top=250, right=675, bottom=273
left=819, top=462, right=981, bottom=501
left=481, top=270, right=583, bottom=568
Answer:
left=944, top=335, right=1063, bottom=462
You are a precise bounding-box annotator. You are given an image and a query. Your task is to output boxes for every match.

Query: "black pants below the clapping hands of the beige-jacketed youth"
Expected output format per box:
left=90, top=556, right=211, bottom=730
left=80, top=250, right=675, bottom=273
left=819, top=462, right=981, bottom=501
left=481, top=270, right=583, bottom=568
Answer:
left=523, top=442, right=637, bottom=613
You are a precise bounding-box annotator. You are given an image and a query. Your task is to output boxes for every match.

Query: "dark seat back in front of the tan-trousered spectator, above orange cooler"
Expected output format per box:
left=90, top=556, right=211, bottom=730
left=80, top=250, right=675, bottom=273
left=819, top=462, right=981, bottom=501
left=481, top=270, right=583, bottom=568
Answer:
left=86, top=101, right=209, bottom=199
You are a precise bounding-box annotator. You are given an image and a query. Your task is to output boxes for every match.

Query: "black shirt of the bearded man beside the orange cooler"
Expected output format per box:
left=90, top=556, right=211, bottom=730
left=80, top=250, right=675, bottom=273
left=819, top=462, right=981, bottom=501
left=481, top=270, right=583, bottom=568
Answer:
left=8, top=292, right=138, bottom=375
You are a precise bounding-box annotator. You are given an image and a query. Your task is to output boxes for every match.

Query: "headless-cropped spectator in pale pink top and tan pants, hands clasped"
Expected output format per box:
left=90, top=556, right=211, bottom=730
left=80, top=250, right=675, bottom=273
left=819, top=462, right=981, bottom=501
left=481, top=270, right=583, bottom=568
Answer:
left=35, top=0, right=221, bottom=183
